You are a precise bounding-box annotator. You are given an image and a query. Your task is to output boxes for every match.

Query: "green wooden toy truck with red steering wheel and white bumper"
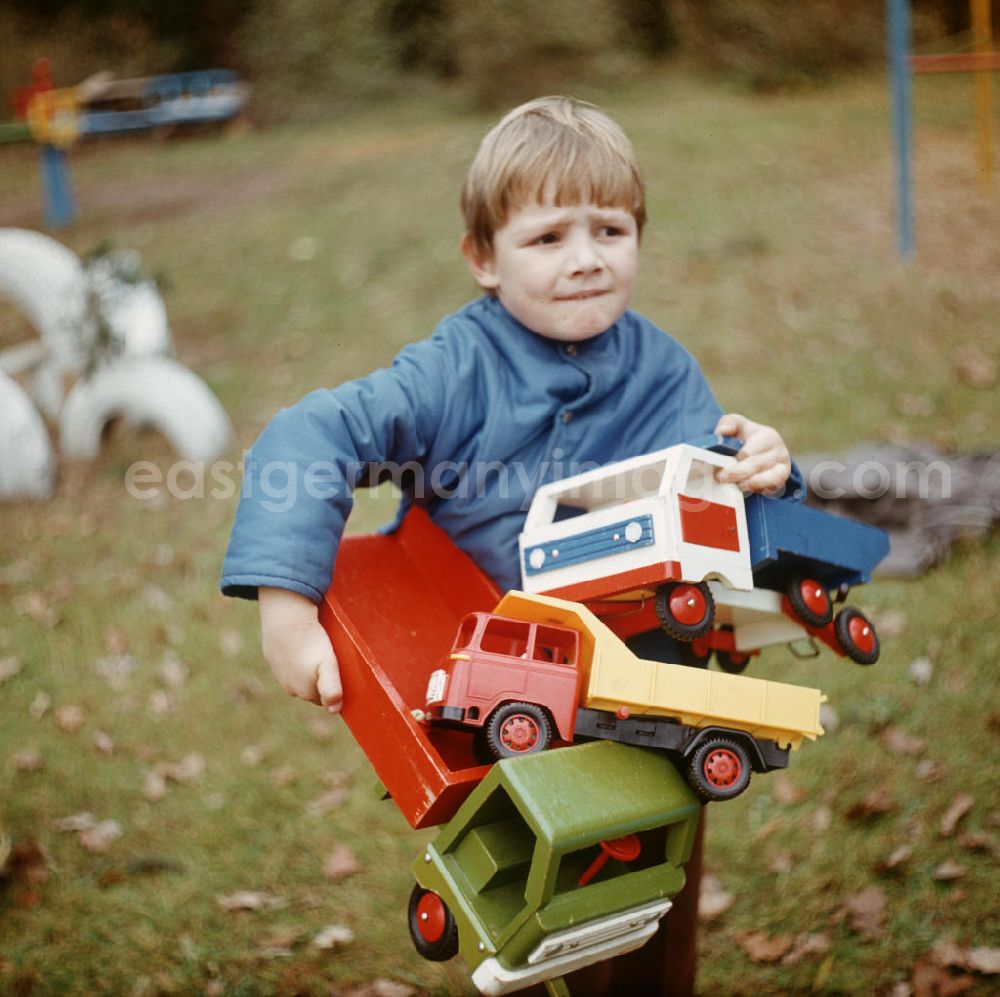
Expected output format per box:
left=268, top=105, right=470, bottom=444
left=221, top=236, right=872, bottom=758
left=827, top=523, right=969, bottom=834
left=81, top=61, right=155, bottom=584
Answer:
left=409, top=741, right=701, bottom=994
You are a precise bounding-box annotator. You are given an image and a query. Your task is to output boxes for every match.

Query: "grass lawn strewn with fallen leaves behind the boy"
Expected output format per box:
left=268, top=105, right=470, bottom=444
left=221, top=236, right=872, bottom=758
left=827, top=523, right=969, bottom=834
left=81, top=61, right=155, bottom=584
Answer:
left=0, top=74, right=1000, bottom=997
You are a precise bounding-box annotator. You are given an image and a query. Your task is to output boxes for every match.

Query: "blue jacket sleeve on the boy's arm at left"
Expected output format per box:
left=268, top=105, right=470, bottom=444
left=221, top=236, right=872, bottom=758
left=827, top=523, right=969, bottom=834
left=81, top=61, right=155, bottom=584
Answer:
left=221, top=339, right=448, bottom=603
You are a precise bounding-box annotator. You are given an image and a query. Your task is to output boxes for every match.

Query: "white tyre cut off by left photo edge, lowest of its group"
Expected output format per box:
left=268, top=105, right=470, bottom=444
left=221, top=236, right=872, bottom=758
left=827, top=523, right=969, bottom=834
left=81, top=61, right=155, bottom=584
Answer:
left=0, top=371, right=56, bottom=500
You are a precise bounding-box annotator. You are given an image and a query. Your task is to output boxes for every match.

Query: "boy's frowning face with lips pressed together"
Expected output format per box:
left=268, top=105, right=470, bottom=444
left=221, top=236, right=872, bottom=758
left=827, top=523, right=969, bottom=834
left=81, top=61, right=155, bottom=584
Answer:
left=462, top=203, right=639, bottom=343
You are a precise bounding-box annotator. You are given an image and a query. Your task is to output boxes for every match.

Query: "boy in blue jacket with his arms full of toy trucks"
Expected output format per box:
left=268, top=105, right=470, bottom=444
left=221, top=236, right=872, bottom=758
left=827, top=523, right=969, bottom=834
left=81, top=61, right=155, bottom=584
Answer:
left=222, top=97, right=801, bottom=713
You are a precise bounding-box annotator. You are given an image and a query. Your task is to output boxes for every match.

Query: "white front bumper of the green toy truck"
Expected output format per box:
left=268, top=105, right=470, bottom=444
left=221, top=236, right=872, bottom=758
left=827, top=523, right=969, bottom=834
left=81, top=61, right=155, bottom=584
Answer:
left=472, top=900, right=672, bottom=995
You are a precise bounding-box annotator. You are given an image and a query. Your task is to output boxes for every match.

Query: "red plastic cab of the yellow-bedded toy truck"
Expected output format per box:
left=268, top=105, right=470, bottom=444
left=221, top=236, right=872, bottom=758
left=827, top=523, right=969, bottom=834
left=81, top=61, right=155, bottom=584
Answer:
left=427, top=613, right=581, bottom=755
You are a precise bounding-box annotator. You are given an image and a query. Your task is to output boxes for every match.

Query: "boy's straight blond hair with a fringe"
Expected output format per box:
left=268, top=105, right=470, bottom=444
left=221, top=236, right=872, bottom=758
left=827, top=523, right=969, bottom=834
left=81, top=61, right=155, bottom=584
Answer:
left=461, top=97, right=646, bottom=257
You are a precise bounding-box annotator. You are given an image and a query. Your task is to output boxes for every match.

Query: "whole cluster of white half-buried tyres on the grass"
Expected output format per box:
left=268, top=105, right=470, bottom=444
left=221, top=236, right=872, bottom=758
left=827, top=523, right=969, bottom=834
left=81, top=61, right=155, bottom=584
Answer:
left=0, top=229, right=232, bottom=498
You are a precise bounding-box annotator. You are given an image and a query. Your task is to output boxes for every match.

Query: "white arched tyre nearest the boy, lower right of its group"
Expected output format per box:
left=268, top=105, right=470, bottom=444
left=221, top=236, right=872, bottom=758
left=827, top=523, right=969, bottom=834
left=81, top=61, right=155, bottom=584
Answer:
left=59, top=357, right=232, bottom=461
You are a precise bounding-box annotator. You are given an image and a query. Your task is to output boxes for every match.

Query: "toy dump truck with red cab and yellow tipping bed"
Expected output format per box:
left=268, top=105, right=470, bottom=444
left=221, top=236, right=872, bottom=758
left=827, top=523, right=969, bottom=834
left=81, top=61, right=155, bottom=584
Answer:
left=426, top=592, right=825, bottom=801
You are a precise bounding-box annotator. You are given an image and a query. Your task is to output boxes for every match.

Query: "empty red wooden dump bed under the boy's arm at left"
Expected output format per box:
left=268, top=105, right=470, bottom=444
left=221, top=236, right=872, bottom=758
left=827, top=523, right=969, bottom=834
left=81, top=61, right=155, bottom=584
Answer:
left=320, top=509, right=500, bottom=827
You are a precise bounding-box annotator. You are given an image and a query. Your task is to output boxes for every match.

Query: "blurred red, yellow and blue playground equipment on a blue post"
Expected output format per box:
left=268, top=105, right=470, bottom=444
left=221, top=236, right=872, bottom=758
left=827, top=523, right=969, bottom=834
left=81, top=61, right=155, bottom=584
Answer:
left=7, top=59, right=249, bottom=228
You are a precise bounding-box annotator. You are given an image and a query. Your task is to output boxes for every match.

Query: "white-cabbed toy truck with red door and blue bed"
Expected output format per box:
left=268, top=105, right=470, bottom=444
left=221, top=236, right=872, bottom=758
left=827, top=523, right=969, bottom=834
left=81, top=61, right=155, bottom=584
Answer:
left=520, top=437, right=889, bottom=671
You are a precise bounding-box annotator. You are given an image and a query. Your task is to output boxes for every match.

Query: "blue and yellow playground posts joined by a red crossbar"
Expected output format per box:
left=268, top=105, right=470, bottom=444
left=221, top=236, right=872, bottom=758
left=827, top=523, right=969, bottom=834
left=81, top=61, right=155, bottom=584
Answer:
left=886, top=0, right=1000, bottom=259
